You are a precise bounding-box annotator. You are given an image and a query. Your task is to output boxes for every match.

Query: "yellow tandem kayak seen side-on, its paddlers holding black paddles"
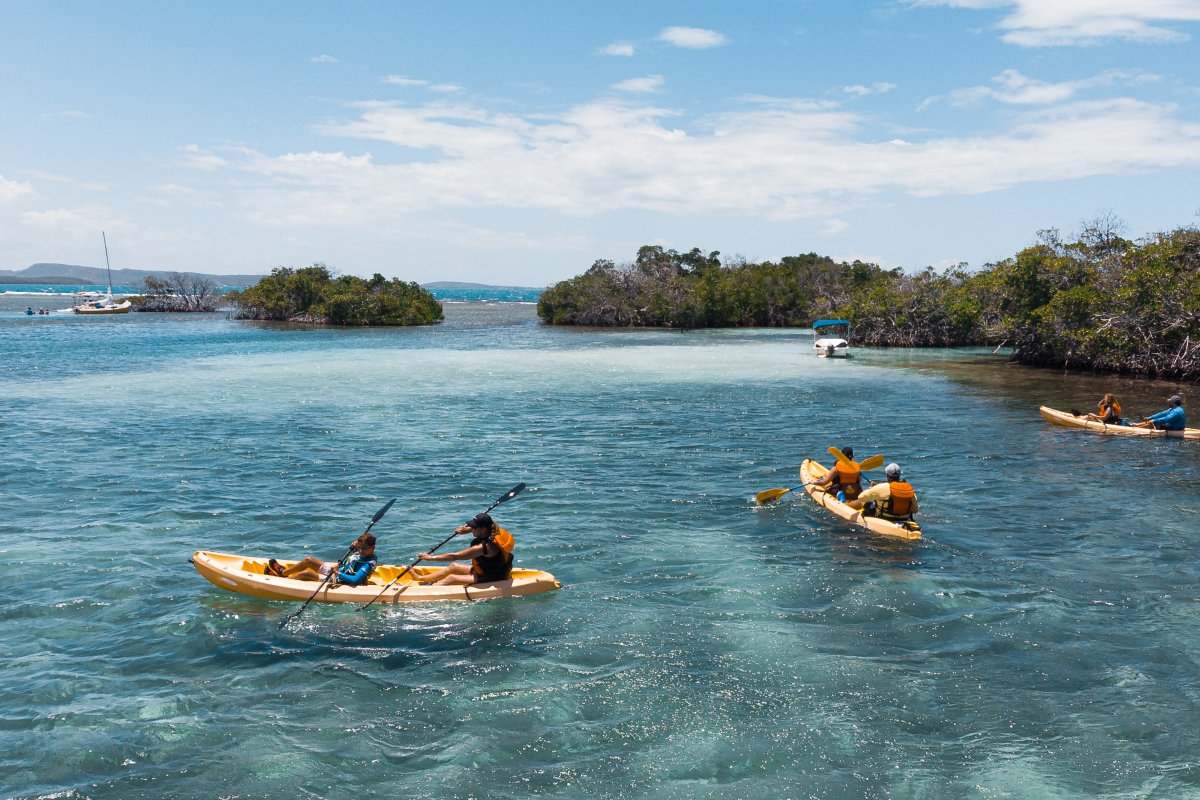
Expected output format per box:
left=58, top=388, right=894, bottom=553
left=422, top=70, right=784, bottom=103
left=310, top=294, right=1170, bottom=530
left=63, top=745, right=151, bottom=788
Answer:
left=192, top=551, right=562, bottom=603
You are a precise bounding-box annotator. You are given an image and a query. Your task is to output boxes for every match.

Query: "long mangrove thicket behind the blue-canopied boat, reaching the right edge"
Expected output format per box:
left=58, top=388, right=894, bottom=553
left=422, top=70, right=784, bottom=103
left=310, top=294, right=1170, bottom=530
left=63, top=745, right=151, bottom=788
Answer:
left=538, top=225, right=1200, bottom=380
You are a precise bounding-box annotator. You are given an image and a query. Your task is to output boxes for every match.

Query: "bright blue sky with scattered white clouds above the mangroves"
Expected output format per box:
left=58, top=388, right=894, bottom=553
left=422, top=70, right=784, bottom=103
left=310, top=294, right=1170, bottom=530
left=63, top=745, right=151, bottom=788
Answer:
left=0, top=0, right=1200, bottom=287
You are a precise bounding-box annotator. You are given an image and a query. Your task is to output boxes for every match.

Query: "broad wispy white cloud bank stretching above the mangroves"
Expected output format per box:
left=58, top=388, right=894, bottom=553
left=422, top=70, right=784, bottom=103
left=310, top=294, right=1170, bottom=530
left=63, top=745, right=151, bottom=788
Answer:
left=211, top=91, right=1200, bottom=227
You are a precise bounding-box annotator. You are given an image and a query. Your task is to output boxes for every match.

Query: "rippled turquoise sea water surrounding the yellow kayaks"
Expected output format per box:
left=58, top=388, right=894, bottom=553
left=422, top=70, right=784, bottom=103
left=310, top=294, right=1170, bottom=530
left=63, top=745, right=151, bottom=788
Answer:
left=0, top=303, right=1200, bottom=800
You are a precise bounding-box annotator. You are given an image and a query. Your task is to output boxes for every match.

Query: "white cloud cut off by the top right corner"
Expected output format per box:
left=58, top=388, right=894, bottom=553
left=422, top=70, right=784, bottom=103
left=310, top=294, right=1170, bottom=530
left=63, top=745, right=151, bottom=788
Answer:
left=910, top=0, right=1200, bottom=47
